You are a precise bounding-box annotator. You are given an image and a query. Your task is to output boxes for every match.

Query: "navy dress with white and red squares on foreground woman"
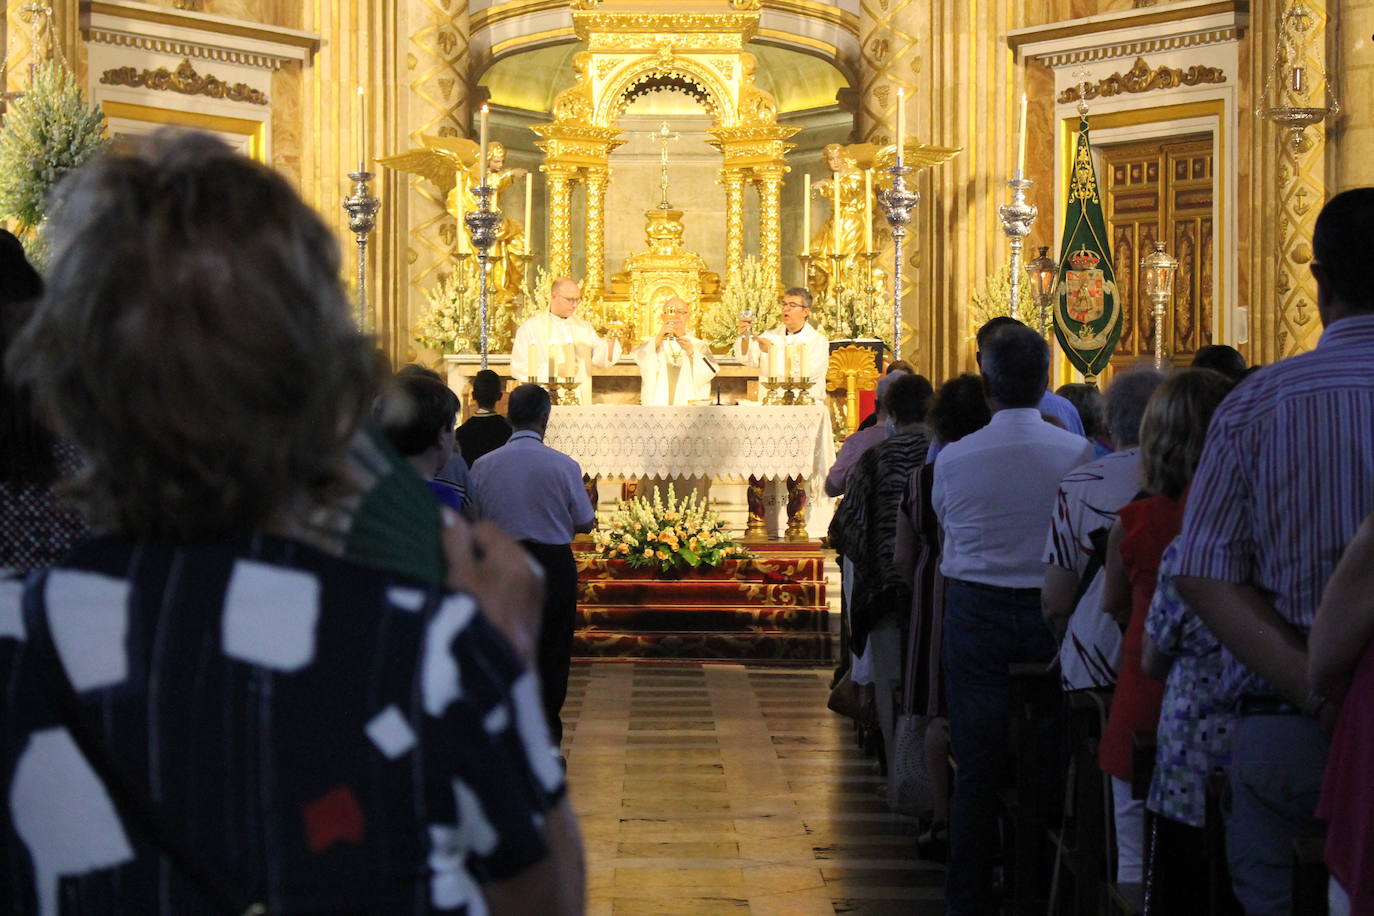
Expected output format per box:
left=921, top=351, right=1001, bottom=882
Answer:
left=0, top=536, right=565, bottom=916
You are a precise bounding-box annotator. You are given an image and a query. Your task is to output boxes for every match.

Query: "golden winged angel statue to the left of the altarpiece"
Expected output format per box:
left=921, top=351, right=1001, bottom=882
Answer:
left=378, top=135, right=529, bottom=301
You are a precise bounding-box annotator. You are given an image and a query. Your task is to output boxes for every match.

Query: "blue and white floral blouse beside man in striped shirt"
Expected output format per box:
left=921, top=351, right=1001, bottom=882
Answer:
left=1145, top=538, right=1231, bottom=827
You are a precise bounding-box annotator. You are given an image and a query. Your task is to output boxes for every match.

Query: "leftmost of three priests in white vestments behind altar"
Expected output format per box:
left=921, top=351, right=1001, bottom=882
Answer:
left=511, top=277, right=620, bottom=404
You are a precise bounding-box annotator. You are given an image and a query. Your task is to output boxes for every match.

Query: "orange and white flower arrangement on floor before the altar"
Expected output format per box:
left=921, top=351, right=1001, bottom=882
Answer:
left=592, top=483, right=752, bottom=573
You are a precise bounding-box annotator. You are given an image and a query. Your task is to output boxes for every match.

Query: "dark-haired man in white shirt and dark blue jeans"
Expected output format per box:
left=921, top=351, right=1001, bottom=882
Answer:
left=930, top=324, right=1092, bottom=916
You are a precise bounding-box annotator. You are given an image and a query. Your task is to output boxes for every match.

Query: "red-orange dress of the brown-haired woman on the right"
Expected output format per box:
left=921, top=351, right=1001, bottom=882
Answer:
left=1098, top=496, right=1183, bottom=780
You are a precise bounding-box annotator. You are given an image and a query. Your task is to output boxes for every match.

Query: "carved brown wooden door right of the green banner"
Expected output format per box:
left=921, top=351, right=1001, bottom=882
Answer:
left=1102, top=135, right=1216, bottom=369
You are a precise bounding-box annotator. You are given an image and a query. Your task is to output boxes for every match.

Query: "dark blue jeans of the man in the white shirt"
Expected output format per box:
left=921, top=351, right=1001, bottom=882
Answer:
left=943, top=581, right=1055, bottom=916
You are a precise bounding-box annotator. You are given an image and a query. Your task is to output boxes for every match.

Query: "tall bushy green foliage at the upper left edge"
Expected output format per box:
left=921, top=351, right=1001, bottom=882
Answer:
left=0, top=60, right=110, bottom=233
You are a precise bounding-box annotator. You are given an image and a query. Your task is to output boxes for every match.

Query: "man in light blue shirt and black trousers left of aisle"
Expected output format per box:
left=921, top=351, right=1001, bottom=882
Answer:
left=473, top=385, right=596, bottom=744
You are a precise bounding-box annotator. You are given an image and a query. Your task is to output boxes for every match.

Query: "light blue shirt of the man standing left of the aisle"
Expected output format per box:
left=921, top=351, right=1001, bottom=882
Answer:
left=470, top=431, right=596, bottom=544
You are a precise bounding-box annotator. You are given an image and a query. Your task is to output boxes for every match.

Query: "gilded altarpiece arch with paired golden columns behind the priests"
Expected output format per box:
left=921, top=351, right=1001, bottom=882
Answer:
left=534, top=0, right=797, bottom=335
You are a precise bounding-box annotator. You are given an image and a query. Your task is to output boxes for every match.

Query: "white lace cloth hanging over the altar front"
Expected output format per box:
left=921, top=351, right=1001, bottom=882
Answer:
left=544, top=404, right=835, bottom=481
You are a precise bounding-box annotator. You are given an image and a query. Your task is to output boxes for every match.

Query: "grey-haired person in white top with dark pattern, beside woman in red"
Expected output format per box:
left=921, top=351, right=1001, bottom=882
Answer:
left=1040, top=369, right=1164, bottom=691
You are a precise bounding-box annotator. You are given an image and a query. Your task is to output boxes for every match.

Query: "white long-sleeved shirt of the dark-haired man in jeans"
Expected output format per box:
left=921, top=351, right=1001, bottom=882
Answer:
left=932, top=408, right=1092, bottom=588
